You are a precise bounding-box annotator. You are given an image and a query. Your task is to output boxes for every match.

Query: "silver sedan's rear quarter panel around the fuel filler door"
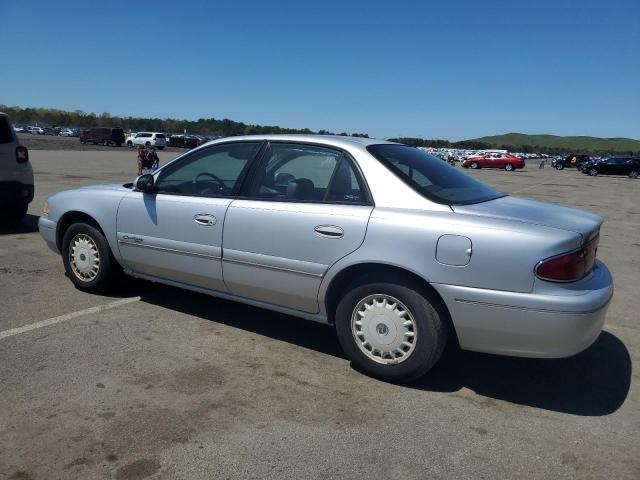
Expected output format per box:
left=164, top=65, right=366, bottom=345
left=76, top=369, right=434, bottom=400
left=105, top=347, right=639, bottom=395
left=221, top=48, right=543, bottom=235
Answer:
left=320, top=208, right=581, bottom=313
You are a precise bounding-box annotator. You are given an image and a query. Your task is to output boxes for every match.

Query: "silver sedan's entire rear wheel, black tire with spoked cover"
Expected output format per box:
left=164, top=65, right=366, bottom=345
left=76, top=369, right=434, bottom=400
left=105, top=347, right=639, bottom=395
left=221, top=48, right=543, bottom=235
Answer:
left=336, top=281, right=447, bottom=382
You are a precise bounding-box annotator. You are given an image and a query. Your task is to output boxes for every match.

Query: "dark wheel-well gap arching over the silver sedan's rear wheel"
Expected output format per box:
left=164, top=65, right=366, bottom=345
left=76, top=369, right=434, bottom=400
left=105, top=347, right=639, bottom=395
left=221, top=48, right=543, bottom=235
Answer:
left=323, top=262, right=459, bottom=345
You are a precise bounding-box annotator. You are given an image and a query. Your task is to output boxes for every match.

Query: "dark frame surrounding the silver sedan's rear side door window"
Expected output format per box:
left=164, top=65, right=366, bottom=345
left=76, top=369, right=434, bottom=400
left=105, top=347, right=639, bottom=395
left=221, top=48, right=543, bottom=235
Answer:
left=236, top=140, right=375, bottom=207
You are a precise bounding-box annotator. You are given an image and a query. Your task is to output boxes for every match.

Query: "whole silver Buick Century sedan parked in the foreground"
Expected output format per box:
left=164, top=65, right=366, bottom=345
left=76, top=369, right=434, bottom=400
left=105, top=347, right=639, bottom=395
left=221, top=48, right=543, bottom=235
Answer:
left=39, top=135, right=613, bottom=381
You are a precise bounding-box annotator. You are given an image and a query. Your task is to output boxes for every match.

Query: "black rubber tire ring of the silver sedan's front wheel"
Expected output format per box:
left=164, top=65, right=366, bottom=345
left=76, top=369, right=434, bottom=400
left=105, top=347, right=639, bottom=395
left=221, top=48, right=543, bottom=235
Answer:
left=62, top=223, right=120, bottom=293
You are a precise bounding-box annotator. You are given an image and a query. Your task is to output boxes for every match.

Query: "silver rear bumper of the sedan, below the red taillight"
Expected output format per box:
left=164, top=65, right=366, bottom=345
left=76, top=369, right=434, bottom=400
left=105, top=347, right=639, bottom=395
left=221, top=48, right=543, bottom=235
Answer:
left=433, top=262, right=613, bottom=358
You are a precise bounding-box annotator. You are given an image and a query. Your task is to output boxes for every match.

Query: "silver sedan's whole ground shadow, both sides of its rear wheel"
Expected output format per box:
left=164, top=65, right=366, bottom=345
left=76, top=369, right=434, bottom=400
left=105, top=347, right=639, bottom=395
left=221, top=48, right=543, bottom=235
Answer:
left=136, top=282, right=632, bottom=416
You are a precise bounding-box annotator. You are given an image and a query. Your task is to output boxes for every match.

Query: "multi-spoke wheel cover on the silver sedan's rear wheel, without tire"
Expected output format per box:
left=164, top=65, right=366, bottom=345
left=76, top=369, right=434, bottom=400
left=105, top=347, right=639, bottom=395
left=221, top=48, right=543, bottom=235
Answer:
left=351, top=293, right=418, bottom=365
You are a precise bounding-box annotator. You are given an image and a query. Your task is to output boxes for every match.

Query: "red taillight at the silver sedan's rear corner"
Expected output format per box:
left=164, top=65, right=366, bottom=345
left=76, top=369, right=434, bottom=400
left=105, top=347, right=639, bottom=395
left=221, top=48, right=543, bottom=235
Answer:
left=536, top=237, right=599, bottom=282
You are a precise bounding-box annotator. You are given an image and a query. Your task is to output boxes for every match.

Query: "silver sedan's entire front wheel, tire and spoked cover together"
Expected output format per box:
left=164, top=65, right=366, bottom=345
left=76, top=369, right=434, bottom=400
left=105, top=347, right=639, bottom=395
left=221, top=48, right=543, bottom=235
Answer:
left=62, top=223, right=117, bottom=293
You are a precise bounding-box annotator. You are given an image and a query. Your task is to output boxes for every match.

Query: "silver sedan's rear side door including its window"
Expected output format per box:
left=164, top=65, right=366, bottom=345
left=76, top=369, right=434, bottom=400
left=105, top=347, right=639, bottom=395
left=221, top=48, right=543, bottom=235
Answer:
left=222, top=142, right=373, bottom=313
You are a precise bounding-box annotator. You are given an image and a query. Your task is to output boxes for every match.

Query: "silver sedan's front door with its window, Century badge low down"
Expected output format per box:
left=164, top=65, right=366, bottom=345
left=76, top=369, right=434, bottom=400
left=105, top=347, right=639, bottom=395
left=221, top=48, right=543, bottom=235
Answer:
left=117, top=141, right=261, bottom=291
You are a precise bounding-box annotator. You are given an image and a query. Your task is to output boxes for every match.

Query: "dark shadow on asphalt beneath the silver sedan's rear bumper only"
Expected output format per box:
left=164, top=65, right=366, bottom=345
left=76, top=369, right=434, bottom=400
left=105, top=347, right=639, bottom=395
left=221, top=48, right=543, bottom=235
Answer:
left=411, top=331, right=632, bottom=416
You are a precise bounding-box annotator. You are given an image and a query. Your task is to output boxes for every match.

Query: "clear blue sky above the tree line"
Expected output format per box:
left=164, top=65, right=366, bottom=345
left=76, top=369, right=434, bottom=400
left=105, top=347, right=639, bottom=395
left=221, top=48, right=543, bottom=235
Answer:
left=0, top=0, right=640, bottom=140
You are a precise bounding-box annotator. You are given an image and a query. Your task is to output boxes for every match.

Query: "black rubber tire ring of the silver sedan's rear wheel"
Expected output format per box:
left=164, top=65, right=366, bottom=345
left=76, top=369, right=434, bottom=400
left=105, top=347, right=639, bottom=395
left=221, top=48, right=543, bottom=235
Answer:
left=336, top=279, right=447, bottom=382
